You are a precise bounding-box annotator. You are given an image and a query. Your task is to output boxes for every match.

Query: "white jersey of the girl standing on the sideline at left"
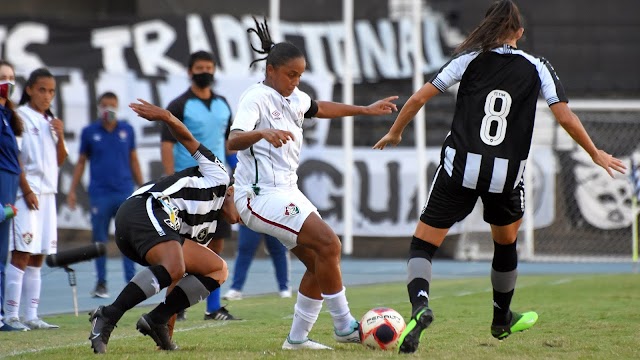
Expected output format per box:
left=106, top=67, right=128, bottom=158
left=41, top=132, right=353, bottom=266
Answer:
left=18, top=105, right=59, bottom=197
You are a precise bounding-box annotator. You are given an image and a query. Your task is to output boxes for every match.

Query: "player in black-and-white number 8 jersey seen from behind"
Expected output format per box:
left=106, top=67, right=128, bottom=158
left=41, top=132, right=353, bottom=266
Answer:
left=374, top=0, right=625, bottom=353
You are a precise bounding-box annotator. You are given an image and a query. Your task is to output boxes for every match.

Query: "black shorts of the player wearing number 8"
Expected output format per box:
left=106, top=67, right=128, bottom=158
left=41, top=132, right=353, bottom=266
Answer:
left=420, top=166, right=524, bottom=229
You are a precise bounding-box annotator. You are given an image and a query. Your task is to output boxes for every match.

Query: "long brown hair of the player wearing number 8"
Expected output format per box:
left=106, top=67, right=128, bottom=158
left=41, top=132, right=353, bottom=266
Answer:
left=455, top=0, right=523, bottom=54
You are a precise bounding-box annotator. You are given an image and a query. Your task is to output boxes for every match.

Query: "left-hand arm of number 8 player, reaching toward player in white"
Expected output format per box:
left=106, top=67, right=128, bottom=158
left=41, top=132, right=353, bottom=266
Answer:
left=373, top=83, right=440, bottom=150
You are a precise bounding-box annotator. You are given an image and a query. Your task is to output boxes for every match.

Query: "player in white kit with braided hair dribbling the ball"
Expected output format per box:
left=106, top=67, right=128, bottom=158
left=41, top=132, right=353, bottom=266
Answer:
left=227, top=19, right=397, bottom=350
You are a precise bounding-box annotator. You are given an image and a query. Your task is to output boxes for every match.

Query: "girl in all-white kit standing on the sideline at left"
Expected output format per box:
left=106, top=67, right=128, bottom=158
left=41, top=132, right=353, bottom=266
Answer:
left=5, top=68, right=67, bottom=330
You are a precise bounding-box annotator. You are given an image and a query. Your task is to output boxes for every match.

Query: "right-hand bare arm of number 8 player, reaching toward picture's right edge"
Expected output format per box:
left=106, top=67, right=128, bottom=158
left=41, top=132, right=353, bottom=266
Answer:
left=550, top=102, right=627, bottom=177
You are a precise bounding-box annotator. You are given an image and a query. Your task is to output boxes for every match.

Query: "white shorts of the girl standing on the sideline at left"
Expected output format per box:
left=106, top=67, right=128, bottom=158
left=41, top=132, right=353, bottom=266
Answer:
left=9, top=194, right=58, bottom=255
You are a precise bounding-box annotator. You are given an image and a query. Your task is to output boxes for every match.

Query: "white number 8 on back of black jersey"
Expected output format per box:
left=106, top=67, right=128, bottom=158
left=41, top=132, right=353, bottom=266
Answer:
left=480, top=90, right=511, bottom=146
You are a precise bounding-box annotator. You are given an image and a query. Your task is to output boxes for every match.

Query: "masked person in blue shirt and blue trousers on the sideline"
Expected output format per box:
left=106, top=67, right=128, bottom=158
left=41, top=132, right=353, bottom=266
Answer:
left=67, top=92, right=142, bottom=298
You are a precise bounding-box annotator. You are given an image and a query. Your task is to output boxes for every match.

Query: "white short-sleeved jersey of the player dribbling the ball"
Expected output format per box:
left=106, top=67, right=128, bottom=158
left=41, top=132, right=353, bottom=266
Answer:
left=231, top=83, right=311, bottom=189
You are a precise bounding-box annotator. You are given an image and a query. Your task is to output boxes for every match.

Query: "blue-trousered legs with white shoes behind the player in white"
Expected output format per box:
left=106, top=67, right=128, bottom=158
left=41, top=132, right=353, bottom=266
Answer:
left=222, top=225, right=291, bottom=300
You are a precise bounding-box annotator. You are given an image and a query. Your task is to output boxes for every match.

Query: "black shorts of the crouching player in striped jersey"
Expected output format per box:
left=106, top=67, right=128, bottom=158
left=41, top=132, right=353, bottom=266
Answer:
left=115, top=195, right=184, bottom=266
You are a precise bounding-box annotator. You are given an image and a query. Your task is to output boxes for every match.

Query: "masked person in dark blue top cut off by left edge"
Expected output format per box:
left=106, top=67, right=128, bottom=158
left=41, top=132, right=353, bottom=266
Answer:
left=0, top=60, right=23, bottom=331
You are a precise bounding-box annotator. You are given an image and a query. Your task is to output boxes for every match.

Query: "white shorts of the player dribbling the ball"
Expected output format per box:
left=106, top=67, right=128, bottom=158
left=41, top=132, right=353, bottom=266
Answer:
left=234, top=188, right=320, bottom=250
